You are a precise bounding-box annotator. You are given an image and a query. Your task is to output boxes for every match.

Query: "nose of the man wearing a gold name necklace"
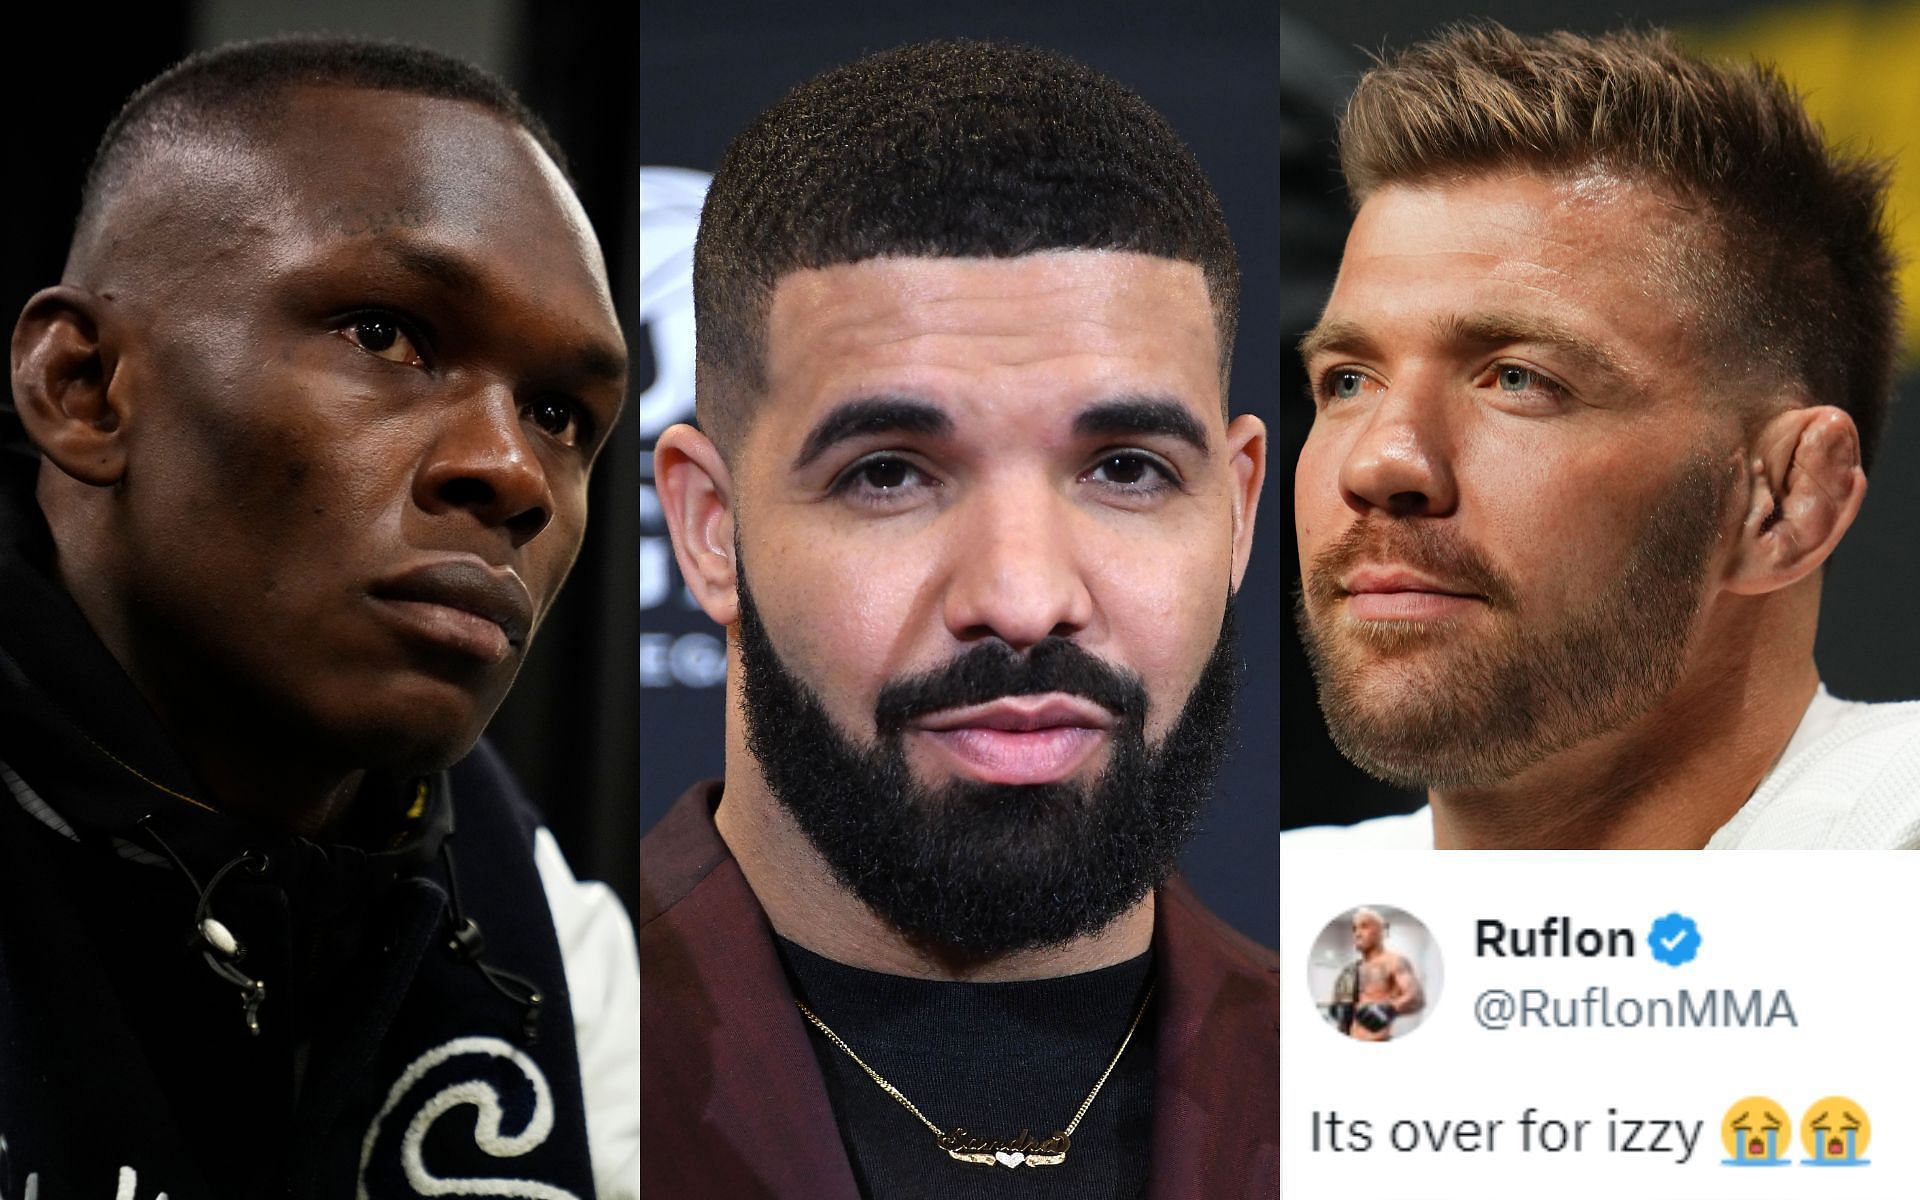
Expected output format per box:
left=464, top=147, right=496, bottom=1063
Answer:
left=943, top=484, right=1092, bottom=649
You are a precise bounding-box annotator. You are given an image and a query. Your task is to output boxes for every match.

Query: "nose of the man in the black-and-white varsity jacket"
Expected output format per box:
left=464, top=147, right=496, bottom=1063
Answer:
left=415, top=380, right=553, bottom=547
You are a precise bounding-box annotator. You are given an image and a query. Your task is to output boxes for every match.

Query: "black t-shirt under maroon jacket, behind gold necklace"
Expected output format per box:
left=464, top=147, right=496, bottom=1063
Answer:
left=780, top=939, right=1158, bottom=1200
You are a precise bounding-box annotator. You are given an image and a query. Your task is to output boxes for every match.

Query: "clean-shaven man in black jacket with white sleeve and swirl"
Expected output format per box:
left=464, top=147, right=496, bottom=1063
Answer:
left=0, top=38, right=637, bottom=1200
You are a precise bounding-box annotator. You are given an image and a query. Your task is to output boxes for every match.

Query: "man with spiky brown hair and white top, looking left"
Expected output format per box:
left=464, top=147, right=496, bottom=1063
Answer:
left=1288, top=25, right=1920, bottom=849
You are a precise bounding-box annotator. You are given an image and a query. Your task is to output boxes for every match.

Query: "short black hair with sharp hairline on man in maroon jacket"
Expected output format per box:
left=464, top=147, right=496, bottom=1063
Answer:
left=693, top=40, right=1240, bottom=453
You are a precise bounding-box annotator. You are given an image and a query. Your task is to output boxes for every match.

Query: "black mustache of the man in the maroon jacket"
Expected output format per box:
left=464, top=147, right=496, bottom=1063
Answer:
left=874, top=637, right=1146, bottom=737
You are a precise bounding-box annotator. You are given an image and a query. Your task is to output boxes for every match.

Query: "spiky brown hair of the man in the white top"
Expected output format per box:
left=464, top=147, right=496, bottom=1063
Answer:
left=1340, top=21, right=1899, bottom=465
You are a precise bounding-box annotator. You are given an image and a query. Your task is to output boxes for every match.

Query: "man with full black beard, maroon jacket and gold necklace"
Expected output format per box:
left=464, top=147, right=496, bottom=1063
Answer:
left=639, top=42, right=1279, bottom=1200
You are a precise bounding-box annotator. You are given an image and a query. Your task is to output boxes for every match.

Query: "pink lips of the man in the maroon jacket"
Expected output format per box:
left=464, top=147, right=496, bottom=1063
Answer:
left=906, top=691, right=1114, bottom=783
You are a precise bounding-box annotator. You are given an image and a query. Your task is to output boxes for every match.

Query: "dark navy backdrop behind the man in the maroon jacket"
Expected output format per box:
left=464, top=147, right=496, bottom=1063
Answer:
left=639, top=0, right=1292, bottom=945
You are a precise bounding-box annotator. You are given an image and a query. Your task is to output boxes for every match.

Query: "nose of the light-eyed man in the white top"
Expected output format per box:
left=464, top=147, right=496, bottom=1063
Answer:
left=1340, top=372, right=1463, bottom=516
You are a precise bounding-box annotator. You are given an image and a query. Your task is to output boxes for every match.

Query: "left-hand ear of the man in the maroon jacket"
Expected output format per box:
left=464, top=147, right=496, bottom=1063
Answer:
left=653, top=424, right=739, bottom=626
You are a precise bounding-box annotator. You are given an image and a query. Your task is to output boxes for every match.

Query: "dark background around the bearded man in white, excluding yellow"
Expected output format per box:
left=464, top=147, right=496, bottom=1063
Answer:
left=1275, top=0, right=1920, bottom=829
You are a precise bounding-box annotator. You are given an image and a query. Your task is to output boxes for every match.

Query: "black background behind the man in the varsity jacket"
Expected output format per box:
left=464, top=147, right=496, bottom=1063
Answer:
left=0, top=0, right=639, bottom=906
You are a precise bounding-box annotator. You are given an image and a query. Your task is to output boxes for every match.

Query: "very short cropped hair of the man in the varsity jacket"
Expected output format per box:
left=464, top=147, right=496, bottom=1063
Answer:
left=75, top=35, right=572, bottom=241
